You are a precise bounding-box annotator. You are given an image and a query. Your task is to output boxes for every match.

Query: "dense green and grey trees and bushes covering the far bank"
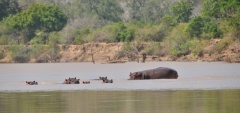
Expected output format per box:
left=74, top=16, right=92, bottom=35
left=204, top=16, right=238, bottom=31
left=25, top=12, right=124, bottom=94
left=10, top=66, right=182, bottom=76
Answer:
left=0, top=0, right=240, bottom=62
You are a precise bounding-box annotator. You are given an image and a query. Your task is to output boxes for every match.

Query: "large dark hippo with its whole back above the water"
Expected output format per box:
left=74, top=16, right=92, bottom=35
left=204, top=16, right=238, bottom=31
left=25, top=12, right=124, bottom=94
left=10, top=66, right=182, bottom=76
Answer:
left=129, top=67, right=178, bottom=80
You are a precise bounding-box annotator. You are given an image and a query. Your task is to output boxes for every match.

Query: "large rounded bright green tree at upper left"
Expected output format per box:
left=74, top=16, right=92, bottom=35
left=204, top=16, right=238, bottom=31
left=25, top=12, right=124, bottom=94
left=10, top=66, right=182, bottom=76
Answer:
left=3, top=4, right=67, bottom=39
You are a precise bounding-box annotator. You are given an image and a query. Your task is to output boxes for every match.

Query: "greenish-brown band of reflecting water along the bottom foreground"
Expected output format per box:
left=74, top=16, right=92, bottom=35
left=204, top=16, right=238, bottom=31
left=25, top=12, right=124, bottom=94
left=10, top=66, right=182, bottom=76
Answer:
left=0, top=90, right=240, bottom=113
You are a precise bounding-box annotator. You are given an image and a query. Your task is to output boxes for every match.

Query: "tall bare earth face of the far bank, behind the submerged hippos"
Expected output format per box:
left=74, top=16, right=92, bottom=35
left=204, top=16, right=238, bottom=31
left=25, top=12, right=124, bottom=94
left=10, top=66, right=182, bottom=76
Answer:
left=60, top=43, right=122, bottom=62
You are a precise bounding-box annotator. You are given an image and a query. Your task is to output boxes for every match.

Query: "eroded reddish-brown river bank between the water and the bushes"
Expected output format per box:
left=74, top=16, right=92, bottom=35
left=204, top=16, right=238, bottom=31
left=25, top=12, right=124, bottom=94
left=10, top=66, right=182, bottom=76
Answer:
left=0, top=40, right=240, bottom=63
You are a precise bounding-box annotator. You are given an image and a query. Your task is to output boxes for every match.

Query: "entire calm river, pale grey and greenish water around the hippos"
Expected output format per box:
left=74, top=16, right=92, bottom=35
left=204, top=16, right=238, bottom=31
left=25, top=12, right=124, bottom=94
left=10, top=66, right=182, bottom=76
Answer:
left=0, top=62, right=240, bottom=113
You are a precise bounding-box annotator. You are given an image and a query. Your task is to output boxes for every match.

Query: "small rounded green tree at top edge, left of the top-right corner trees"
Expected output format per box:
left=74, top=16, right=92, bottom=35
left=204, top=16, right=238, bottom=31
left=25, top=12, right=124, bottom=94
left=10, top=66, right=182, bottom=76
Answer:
left=171, top=1, right=192, bottom=22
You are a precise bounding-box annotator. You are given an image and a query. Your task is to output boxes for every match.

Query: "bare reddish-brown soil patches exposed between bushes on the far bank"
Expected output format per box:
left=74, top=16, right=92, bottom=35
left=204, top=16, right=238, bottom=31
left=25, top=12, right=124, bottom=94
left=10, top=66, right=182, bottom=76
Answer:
left=0, top=39, right=240, bottom=63
